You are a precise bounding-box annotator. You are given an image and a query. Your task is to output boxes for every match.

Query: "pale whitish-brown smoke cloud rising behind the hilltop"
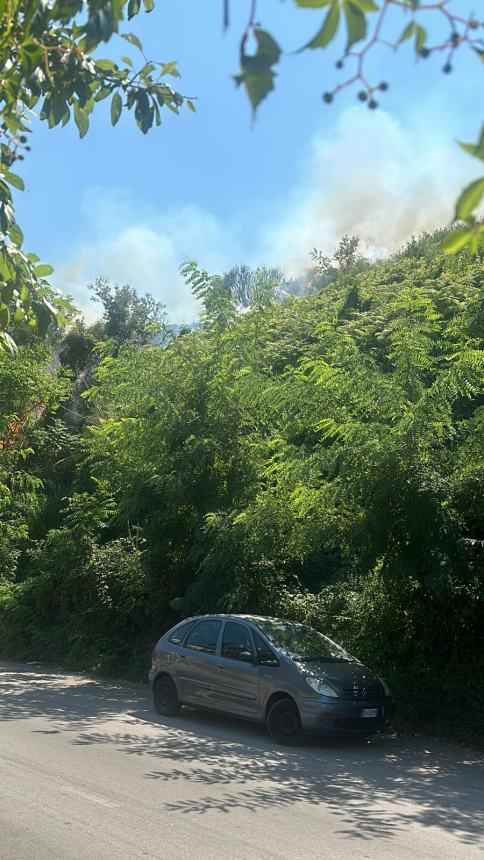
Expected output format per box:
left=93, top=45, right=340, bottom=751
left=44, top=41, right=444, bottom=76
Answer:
left=56, top=107, right=475, bottom=321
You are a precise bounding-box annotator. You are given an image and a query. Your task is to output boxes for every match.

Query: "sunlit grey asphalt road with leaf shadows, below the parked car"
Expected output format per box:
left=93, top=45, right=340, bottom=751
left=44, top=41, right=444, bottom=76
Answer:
left=0, top=662, right=484, bottom=860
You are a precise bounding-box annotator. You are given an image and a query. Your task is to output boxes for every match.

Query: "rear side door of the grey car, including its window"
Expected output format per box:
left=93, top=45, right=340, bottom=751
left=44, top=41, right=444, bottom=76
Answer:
left=175, top=618, right=222, bottom=708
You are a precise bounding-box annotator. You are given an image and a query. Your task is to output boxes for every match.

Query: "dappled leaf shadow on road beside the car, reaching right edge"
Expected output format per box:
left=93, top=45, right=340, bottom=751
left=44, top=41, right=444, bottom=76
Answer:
left=76, top=712, right=484, bottom=844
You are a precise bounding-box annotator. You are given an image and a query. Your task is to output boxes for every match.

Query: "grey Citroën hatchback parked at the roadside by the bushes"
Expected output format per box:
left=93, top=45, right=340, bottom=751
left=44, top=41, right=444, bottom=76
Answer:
left=149, top=615, right=395, bottom=744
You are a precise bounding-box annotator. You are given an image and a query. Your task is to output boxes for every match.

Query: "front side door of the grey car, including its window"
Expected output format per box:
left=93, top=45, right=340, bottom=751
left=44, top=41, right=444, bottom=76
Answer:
left=215, top=621, right=260, bottom=717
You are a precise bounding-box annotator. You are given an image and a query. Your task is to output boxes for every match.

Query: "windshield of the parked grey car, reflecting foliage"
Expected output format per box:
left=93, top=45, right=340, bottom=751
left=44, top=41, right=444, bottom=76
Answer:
left=257, top=620, right=357, bottom=663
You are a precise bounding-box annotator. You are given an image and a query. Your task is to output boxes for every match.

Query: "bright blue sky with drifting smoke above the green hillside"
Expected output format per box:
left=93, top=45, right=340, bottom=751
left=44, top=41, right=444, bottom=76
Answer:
left=17, top=0, right=482, bottom=320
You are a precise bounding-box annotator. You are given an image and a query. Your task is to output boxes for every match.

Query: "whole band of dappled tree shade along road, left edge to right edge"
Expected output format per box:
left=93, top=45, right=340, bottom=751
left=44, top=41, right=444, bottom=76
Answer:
left=0, top=664, right=484, bottom=846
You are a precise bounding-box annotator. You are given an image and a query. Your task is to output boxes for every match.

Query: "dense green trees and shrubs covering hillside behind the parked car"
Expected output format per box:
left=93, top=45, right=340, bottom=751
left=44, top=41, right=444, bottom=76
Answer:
left=0, top=228, right=484, bottom=737
